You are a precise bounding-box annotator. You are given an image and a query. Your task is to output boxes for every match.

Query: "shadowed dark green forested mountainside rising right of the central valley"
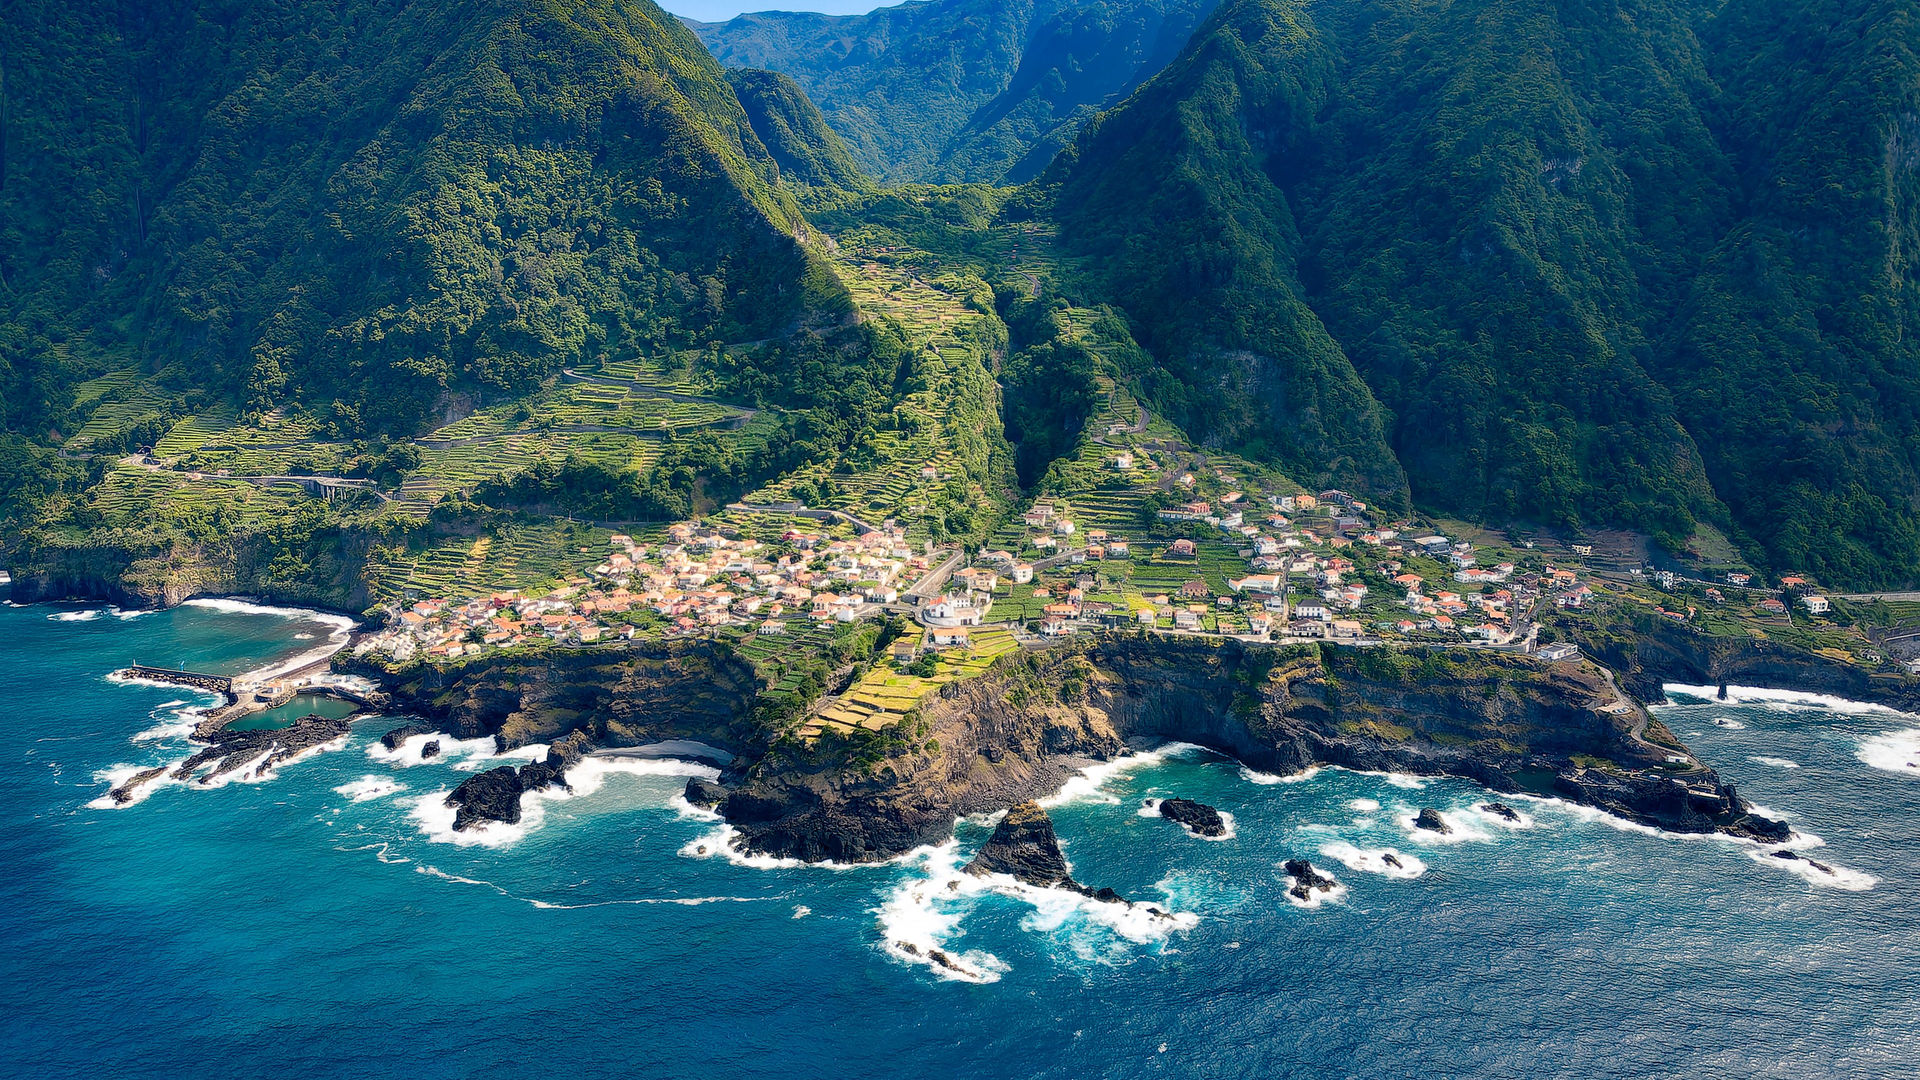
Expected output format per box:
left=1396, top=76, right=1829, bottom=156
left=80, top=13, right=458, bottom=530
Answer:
left=1043, top=0, right=1920, bottom=580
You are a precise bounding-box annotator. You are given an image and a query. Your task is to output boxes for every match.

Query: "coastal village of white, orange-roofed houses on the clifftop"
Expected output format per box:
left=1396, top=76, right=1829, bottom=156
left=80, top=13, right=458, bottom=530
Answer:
left=359, top=468, right=1594, bottom=663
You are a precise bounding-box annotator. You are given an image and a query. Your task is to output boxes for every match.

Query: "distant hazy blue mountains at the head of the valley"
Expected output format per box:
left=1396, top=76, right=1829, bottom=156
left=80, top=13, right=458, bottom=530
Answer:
left=691, top=0, right=1217, bottom=183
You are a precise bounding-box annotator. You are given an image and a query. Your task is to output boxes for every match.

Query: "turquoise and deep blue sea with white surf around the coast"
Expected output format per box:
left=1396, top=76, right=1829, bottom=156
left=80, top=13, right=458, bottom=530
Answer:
left=0, top=605, right=1920, bottom=1080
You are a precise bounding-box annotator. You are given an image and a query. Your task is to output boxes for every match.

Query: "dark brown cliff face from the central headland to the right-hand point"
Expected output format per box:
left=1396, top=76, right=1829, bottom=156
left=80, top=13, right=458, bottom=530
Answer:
left=722, top=640, right=1786, bottom=861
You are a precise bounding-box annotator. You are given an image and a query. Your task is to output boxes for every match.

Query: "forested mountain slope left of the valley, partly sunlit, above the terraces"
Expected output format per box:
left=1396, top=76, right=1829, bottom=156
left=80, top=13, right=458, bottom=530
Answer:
left=0, top=0, right=851, bottom=434
